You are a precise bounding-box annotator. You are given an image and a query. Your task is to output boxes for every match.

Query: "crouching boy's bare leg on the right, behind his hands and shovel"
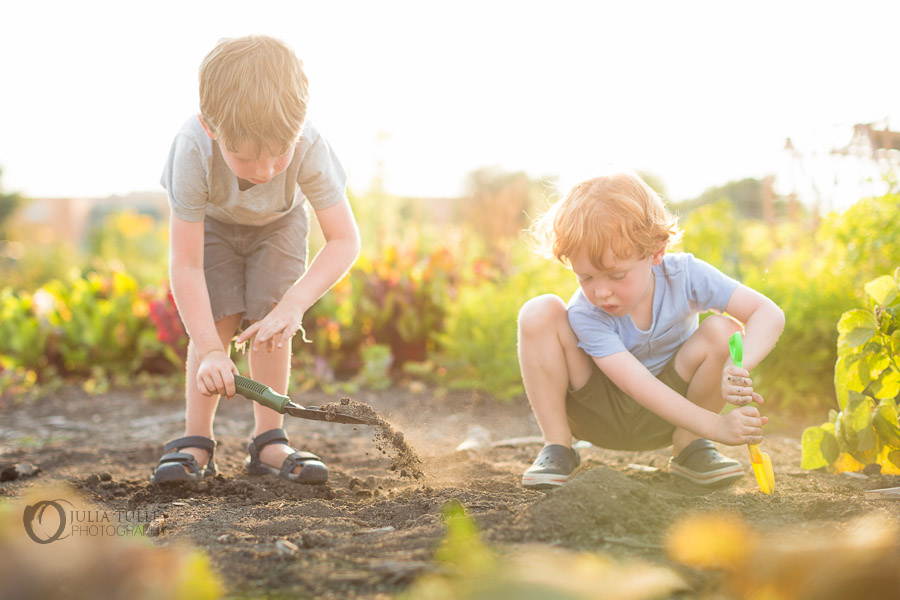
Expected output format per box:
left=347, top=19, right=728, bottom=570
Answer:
left=672, top=315, right=741, bottom=456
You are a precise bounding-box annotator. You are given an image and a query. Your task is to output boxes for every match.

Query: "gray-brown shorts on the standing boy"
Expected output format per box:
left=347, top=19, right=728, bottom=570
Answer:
left=203, top=204, right=309, bottom=327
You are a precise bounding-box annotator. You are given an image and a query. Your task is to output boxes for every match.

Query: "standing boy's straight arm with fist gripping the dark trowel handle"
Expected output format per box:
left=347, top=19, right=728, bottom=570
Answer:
left=169, top=213, right=237, bottom=397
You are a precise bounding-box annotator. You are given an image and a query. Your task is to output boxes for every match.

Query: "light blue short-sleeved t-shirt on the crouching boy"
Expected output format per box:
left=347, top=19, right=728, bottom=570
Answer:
left=568, top=252, right=738, bottom=375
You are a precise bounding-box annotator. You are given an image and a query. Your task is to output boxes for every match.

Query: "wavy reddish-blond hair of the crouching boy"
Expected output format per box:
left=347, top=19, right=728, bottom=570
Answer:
left=531, top=171, right=682, bottom=269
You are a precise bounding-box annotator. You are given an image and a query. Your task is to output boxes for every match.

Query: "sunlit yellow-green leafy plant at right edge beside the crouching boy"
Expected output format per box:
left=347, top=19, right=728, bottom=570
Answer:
left=802, top=268, right=900, bottom=475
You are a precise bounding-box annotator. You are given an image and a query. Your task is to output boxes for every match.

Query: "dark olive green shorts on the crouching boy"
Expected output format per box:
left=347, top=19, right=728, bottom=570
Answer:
left=566, top=358, right=688, bottom=450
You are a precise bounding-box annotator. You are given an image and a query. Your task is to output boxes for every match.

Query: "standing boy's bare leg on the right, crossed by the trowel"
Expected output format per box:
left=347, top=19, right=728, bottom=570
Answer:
left=249, top=332, right=302, bottom=473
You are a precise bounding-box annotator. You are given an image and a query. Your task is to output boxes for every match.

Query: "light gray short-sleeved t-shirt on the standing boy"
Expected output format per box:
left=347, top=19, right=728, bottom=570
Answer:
left=160, top=115, right=347, bottom=226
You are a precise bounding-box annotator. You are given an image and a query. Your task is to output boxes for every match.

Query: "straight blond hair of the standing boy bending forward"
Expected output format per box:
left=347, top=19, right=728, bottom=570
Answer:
left=200, top=35, right=309, bottom=157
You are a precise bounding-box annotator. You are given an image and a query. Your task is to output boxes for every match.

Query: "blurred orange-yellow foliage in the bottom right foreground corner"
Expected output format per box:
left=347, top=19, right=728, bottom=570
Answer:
left=666, top=513, right=900, bottom=600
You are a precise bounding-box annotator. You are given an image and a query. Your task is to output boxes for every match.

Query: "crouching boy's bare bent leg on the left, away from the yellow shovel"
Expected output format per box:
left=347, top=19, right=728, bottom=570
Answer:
left=518, top=294, right=591, bottom=447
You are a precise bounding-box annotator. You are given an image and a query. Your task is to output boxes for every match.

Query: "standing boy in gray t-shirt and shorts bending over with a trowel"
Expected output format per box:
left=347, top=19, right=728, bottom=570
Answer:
left=152, top=36, right=360, bottom=484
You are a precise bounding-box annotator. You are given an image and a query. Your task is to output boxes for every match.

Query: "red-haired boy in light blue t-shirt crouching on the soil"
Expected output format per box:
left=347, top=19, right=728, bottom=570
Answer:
left=519, top=172, right=784, bottom=488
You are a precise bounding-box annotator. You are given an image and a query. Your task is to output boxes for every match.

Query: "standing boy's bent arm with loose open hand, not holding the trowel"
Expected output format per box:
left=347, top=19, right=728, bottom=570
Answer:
left=237, top=201, right=360, bottom=351
